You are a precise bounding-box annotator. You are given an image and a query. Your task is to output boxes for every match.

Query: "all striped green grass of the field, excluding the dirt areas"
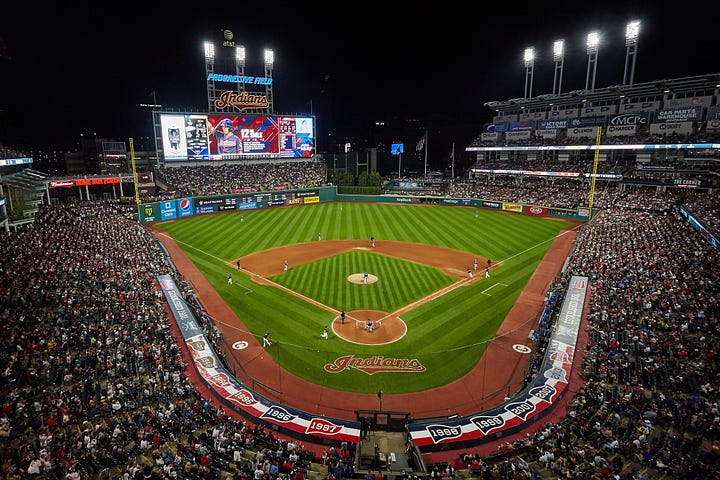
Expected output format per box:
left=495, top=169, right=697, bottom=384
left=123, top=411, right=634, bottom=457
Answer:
left=157, top=203, right=569, bottom=394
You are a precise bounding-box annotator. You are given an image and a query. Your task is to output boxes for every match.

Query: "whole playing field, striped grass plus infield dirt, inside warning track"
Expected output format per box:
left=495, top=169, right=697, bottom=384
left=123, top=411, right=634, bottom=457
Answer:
left=154, top=202, right=571, bottom=400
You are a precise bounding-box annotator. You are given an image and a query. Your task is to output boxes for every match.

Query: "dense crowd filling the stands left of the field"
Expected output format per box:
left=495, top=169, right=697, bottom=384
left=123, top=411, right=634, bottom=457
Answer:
left=0, top=201, right=350, bottom=480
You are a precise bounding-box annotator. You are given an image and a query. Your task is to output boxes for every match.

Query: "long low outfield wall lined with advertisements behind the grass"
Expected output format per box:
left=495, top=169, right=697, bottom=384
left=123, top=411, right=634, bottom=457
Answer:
left=138, top=187, right=597, bottom=224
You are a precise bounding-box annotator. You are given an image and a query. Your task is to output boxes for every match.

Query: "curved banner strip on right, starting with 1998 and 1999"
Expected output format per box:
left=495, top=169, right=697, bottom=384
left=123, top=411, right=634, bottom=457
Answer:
left=408, top=276, right=588, bottom=453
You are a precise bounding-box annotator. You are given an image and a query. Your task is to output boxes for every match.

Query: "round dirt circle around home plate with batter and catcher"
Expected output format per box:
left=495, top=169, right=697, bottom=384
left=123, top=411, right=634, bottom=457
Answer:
left=332, top=310, right=408, bottom=345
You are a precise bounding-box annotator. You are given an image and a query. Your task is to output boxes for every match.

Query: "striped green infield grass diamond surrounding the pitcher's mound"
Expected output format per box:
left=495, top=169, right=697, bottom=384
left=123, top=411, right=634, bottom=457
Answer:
left=270, top=251, right=458, bottom=313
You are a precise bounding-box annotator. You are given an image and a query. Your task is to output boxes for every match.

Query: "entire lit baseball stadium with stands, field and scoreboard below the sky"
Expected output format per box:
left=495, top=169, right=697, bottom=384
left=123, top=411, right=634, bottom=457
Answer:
left=0, top=29, right=720, bottom=480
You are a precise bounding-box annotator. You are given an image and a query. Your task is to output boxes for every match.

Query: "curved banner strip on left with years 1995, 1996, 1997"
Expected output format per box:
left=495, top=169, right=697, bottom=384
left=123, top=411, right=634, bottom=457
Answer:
left=157, top=275, right=360, bottom=443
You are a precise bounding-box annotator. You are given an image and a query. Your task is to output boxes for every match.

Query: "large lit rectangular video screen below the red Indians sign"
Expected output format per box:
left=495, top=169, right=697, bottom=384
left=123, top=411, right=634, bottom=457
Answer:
left=160, top=114, right=315, bottom=161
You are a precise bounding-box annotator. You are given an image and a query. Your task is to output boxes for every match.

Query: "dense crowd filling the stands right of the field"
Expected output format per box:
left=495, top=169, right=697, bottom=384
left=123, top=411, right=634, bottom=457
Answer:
left=464, top=197, right=720, bottom=479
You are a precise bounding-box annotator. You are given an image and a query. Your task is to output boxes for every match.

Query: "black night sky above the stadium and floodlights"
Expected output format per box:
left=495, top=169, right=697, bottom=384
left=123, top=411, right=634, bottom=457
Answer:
left=0, top=1, right=720, bottom=163
